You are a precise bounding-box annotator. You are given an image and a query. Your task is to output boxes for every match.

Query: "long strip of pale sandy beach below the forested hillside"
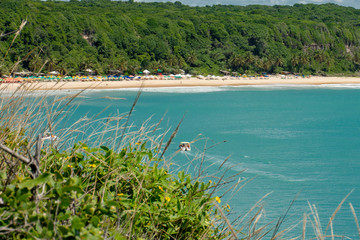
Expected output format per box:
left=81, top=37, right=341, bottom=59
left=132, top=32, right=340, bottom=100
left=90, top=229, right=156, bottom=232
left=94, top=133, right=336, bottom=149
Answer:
left=0, top=76, right=360, bottom=91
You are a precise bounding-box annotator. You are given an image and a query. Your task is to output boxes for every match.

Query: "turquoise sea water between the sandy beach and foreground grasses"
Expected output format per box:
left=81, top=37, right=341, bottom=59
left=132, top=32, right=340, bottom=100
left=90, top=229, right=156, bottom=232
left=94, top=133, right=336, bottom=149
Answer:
left=64, top=85, right=360, bottom=238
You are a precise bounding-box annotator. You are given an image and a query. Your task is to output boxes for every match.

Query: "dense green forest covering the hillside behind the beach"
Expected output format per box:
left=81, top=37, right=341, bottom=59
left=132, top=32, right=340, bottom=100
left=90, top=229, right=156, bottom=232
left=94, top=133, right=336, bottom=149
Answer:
left=0, top=0, right=360, bottom=75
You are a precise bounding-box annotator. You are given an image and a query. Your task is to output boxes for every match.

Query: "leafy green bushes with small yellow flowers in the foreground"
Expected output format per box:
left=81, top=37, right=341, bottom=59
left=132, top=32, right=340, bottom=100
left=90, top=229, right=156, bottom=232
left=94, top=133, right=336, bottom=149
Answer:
left=0, top=143, right=228, bottom=239
